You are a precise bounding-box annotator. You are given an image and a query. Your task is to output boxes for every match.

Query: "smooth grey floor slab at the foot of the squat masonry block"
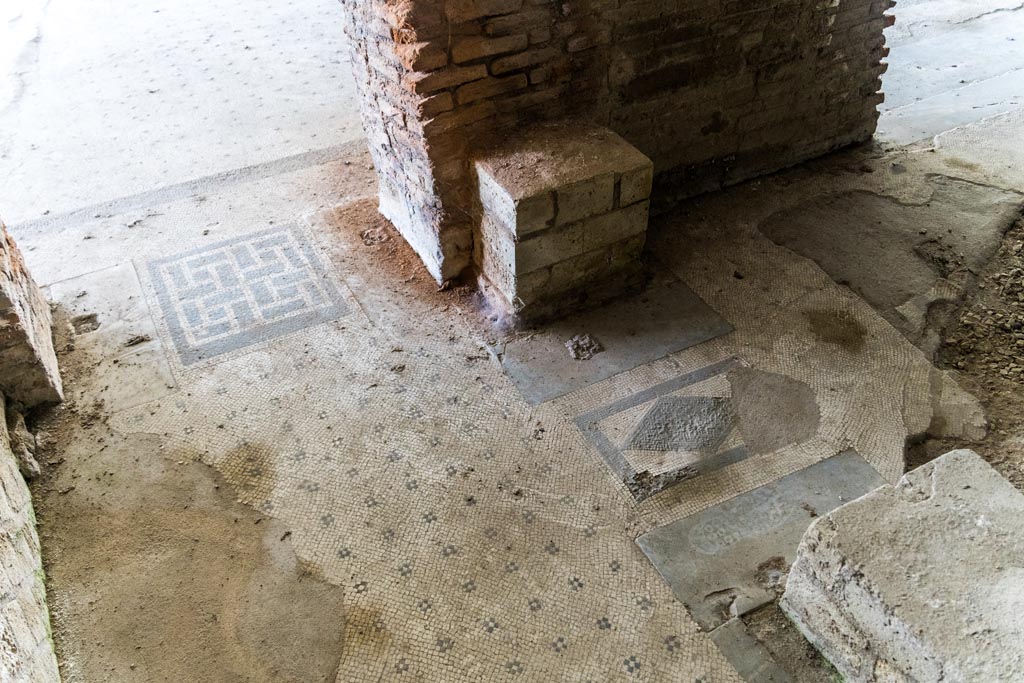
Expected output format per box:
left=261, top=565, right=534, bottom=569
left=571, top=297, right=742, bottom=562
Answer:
left=499, top=281, right=732, bottom=405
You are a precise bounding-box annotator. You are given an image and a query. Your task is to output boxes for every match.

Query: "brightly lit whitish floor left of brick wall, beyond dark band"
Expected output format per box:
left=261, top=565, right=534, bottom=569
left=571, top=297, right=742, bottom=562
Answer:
left=0, top=0, right=362, bottom=224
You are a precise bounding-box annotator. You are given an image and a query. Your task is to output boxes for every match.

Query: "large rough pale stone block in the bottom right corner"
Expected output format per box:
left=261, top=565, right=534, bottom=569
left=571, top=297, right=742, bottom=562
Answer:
left=781, top=451, right=1024, bottom=683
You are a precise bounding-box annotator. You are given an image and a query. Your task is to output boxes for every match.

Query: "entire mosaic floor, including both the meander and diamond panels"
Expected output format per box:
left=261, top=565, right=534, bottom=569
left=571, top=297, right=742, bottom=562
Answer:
left=32, top=178, right=977, bottom=683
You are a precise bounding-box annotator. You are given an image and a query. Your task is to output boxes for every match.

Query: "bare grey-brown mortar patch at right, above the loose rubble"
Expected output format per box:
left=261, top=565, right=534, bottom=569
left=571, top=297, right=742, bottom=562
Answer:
left=760, top=174, right=1024, bottom=353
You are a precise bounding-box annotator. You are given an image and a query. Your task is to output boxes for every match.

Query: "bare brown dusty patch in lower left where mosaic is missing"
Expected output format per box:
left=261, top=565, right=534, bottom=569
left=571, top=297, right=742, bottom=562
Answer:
left=36, top=430, right=345, bottom=683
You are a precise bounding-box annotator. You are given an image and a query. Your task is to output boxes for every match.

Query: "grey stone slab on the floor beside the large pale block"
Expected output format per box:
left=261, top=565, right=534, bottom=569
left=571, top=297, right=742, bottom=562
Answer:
left=637, top=451, right=885, bottom=630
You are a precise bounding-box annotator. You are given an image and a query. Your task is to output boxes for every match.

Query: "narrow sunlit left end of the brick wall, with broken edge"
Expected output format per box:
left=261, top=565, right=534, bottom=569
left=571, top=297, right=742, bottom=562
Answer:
left=341, top=0, right=475, bottom=283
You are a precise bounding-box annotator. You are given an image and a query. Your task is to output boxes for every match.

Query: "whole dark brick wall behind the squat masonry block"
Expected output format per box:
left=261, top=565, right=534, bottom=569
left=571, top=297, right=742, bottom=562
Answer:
left=341, top=0, right=892, bottom=281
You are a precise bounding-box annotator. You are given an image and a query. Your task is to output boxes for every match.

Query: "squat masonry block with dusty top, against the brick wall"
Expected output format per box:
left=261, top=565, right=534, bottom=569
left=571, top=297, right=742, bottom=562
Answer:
left=476, top=123, right=651, bottom=317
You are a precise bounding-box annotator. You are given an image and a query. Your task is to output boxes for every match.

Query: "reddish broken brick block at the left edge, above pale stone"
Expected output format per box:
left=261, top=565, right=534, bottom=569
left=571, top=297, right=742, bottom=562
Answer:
left=0, top=221, right=63, bottom=407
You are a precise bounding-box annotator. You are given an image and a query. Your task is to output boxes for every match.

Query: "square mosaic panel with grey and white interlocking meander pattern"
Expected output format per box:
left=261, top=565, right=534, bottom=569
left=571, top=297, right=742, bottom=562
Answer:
left=148, top=226, right=348, bottom=366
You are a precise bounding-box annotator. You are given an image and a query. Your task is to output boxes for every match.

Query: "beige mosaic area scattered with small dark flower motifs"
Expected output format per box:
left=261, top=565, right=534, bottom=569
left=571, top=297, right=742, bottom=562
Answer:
left=115, top=236, right=732, bottom=682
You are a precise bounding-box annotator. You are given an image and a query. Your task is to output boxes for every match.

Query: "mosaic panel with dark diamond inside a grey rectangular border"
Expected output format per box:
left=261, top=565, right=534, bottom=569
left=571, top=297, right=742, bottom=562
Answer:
left=575, top=359, right=751, bottom=501
